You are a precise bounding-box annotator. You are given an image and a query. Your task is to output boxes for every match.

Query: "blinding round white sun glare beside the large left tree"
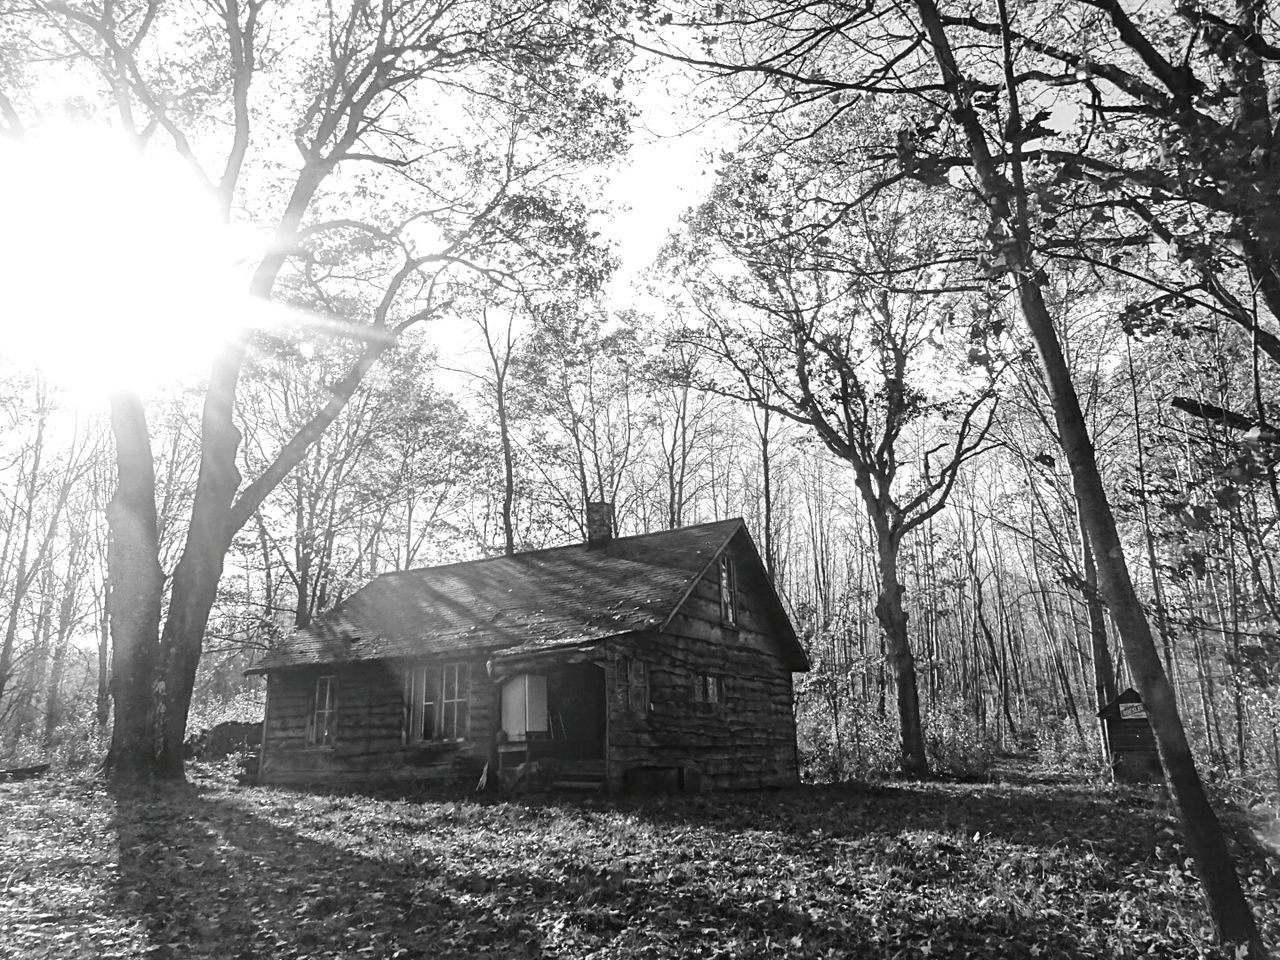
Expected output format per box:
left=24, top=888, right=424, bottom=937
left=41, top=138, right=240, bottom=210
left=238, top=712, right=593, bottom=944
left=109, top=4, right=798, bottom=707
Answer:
left=0, top=127, right=250, bottom=397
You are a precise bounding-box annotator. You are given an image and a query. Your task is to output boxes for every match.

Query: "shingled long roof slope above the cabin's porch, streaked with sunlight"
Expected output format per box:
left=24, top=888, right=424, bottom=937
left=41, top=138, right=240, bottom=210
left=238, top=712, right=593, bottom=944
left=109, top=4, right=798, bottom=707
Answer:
left=247, top=520, right=745, bottom=673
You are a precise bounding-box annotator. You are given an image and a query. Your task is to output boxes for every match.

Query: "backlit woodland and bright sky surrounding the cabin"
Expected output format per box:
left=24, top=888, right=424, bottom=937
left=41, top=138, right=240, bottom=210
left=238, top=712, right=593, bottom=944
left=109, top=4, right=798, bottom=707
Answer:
left=0, top=0, right=1280, bottom=956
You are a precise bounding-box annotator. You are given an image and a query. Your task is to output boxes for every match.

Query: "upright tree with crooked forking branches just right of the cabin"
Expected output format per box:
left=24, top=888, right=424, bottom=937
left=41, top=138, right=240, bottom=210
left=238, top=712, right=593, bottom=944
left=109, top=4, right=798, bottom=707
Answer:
left=669, top=124, right=998, bottom=776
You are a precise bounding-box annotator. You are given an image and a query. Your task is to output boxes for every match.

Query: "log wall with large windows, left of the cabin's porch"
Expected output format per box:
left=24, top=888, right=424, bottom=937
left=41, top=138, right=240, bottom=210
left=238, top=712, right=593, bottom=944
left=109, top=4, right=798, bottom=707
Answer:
left=260, top=658, right=498, bottom=783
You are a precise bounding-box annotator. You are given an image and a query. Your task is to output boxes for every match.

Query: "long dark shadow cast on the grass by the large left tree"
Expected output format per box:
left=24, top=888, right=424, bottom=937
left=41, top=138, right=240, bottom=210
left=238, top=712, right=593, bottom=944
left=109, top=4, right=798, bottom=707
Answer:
left=111, top=785, right=540, bottom=959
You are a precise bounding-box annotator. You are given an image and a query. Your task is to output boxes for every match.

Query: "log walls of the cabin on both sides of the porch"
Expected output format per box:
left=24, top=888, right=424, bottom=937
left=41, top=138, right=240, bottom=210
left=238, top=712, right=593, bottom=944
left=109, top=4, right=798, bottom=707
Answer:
left=261, top=534, right=797, bottom=792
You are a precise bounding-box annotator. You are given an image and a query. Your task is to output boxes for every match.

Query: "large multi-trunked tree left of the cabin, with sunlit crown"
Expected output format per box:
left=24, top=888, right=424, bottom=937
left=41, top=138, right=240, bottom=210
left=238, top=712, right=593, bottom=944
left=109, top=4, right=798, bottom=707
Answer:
left=4, top=0, right=626, bottom=777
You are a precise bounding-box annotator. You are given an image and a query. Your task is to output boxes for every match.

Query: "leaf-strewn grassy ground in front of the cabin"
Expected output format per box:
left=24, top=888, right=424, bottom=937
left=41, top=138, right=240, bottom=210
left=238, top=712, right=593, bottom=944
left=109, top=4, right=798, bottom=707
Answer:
left=0, top=771, right=1280, bottom=960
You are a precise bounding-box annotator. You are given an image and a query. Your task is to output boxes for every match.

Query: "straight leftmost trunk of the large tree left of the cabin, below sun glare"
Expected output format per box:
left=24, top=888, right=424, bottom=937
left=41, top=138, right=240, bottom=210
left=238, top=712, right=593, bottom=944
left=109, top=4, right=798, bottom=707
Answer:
left=106, top=393, right=164, bottom=777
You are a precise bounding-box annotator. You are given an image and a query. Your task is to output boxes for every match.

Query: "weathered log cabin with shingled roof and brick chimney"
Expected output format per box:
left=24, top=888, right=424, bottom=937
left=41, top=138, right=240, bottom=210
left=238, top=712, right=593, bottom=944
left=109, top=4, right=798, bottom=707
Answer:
left=248, top=504, right=809, bottom=792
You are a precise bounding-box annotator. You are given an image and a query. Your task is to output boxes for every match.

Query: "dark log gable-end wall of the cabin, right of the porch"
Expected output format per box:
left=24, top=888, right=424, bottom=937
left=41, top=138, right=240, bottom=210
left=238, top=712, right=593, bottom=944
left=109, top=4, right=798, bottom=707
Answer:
left=607, top=529, right=796, bottom=790
